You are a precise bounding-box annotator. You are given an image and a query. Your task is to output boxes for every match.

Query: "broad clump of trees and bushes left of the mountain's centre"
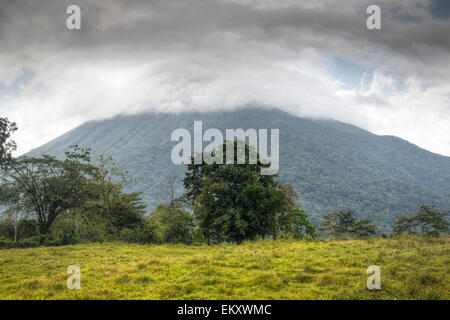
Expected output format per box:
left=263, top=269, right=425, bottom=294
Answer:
left=0, top=146, right=151, bottom=246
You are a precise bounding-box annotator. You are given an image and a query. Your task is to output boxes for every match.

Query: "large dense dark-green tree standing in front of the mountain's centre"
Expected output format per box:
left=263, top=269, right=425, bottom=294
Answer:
left=184, top=142, right=312, bottom=243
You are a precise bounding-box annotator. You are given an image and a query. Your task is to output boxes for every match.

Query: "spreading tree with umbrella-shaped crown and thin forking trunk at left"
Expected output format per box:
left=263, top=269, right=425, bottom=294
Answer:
left=3, top=146, right=96, bottom=234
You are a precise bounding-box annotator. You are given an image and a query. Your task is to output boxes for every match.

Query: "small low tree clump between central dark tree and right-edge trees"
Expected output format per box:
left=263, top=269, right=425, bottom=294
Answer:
left=319, top=210, right=377, bottom=239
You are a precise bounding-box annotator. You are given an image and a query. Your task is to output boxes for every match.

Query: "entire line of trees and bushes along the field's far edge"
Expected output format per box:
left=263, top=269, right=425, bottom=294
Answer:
left=0, top=118, right=449, bottom=247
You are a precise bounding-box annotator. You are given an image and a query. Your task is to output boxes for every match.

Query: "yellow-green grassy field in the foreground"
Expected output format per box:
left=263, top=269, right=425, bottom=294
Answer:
left=0, top=236, right=450, bottom=299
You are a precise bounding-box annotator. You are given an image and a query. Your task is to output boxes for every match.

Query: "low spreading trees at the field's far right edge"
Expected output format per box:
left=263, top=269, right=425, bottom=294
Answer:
left=394, top=205, right=449, bottom=237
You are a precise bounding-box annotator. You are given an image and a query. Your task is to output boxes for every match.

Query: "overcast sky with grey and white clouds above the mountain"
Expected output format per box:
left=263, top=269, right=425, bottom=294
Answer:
left=0, top=0, right=450, bottom=155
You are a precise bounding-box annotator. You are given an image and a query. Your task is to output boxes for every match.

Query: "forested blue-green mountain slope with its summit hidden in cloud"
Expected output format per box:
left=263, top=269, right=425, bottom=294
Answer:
left=29, top=108, right=450, bottom=231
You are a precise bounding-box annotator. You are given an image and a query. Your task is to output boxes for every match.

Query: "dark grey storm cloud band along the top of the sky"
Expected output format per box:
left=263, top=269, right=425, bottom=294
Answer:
left=0, top=0, right=450, bottom=57
